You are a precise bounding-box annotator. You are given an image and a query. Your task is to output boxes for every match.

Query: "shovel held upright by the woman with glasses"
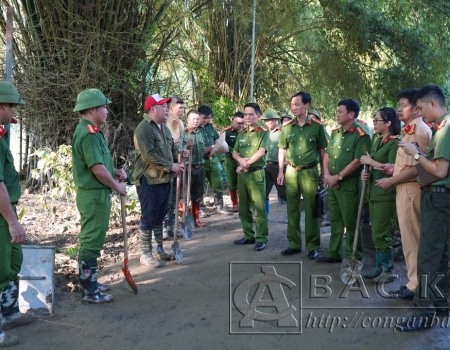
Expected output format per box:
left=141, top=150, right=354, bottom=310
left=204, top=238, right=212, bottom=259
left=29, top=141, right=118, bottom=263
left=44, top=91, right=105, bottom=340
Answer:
left=341, top=164, right=369, bottom=284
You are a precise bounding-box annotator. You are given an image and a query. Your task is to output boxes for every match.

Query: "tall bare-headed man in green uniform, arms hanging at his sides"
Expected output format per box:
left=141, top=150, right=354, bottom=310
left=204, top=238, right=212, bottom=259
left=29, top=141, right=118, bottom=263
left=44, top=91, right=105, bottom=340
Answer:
left=278, top=91, right=327, bottom=260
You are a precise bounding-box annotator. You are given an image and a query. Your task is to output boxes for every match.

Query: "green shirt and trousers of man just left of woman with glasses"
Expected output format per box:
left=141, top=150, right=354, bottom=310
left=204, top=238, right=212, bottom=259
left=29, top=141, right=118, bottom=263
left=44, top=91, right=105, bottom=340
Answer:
left=327, top=121, right=370, bottom=260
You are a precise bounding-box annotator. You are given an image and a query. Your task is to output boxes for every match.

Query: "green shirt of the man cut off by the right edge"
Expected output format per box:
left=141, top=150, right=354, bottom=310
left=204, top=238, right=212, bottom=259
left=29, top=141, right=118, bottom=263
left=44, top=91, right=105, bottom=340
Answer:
left=427, top=113, right=450, bottom=188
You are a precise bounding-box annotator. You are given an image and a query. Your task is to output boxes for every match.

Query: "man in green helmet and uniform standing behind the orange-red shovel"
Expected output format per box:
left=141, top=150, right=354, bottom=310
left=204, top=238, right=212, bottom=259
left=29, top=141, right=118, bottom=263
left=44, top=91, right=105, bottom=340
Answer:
left=72, top=89, right=127, bottom=304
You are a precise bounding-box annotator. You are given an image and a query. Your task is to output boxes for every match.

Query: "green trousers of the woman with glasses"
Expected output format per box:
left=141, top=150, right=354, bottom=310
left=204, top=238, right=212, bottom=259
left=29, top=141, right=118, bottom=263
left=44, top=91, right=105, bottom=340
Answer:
left=369, top=200, right=397, bottom=253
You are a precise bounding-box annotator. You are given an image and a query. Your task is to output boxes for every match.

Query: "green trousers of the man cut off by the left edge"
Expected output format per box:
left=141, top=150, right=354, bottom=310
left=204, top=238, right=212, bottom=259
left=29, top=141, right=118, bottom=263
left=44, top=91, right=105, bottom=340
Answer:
left=0, top=206, right=23, bottom=291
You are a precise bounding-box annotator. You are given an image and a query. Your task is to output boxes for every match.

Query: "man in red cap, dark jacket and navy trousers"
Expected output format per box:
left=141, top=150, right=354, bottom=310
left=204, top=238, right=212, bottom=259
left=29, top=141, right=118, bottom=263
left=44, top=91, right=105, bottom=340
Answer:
left=134, top=94, right=188, bottom=267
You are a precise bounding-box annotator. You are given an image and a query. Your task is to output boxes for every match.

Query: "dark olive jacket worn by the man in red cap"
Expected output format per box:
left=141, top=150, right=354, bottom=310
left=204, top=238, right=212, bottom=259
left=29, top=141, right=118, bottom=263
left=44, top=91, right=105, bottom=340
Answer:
left=133, top=115, right=178, bottom=186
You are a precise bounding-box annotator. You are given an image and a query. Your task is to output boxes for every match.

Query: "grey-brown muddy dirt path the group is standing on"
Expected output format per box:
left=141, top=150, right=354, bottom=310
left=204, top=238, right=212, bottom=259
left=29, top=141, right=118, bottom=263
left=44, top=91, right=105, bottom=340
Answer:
left=9, top=193, right=449, bottom=350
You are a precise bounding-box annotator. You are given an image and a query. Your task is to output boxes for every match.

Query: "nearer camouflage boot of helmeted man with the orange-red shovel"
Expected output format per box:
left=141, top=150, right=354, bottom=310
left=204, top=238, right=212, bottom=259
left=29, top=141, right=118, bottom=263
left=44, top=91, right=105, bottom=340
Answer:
left=78, top=259, right=114, bottom=304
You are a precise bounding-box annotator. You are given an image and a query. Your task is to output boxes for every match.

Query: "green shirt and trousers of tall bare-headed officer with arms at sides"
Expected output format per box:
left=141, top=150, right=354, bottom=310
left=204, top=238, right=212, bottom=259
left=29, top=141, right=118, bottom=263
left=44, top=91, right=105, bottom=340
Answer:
left=278, top=116, right=327, bottom=250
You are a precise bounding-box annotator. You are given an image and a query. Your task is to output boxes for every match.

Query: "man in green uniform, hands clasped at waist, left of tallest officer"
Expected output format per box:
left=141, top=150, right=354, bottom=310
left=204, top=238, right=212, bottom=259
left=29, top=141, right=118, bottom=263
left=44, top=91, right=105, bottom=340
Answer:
left=233, top=102, right=269, bottom=251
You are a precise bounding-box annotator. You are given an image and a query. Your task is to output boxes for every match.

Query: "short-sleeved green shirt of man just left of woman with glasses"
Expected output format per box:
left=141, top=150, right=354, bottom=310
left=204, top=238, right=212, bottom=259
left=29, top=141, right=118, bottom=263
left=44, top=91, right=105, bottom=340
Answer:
left=327, top=121, right=370, bottom=177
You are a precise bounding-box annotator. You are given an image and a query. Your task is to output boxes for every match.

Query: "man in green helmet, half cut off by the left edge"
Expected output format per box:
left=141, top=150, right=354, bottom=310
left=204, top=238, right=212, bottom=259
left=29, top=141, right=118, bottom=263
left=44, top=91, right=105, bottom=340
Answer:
left=0, top=81, right=34, bottom=347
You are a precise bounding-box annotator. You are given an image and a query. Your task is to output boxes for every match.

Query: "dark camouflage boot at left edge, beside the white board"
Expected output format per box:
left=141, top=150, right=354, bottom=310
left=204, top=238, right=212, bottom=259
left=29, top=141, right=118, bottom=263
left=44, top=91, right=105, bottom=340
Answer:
left=0, top=280, right=34, bottom=330
